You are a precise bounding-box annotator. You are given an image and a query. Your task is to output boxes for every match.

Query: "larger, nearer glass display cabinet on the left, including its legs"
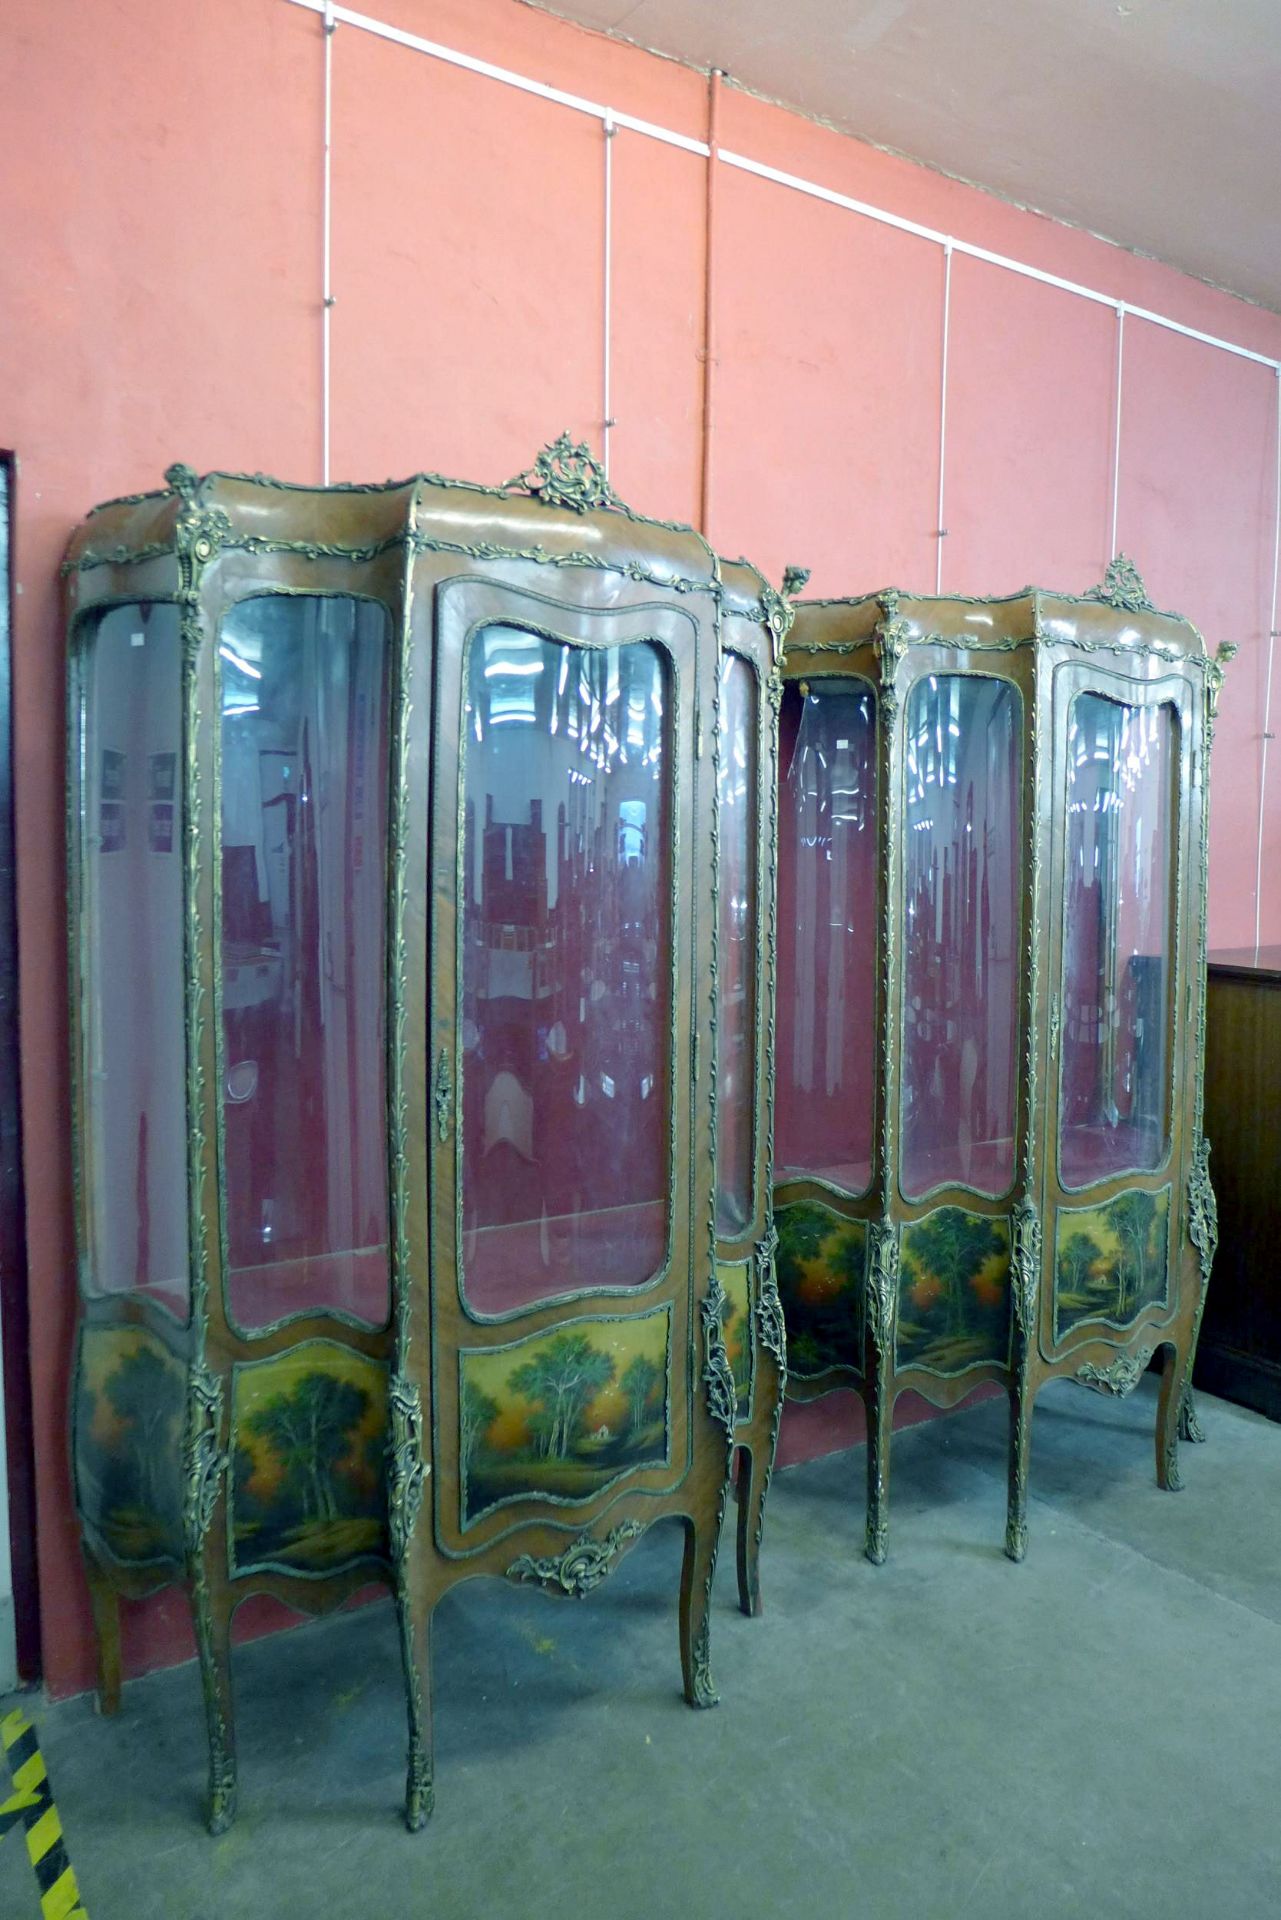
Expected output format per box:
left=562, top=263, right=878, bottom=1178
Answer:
left=65, top=436, right=789, bottom=1830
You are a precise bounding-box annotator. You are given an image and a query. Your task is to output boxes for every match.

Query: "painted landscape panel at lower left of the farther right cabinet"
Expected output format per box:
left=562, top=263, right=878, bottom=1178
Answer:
left=774, top=1200, right=868, bottom=1379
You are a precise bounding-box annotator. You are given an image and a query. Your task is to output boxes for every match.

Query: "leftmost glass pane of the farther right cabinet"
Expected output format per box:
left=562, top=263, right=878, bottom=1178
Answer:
left=776, top=678, right=878, bottom=1194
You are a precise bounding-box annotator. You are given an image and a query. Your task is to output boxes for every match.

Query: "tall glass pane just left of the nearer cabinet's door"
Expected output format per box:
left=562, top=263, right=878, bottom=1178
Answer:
left=219, top=593, right=390, bottom=1331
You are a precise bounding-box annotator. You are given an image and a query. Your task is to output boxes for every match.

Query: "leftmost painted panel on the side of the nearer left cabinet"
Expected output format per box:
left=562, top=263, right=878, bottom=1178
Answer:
left=75, top=1327, right=186, bottom=1563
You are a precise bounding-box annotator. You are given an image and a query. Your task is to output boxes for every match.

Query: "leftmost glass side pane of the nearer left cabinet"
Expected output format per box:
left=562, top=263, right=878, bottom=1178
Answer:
left=79, top=605, right=188, bottom=1319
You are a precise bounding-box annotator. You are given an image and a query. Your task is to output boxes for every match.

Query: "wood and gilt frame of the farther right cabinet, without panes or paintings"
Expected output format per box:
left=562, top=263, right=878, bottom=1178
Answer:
left=774, top=559, right=1235, bottom=1561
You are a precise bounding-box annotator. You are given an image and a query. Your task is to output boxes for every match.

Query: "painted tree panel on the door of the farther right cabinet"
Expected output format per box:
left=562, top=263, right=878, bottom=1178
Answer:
left=1054, top=1187, right=1170, bottom=1334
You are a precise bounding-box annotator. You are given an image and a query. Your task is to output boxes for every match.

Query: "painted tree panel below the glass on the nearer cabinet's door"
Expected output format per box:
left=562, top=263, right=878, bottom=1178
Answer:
left=459, top=1306, right=672, bottom=1526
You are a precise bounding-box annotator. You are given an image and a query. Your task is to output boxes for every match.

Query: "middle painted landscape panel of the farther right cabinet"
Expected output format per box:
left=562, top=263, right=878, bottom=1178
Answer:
left=897, top=1206, right=1010, bottom=1373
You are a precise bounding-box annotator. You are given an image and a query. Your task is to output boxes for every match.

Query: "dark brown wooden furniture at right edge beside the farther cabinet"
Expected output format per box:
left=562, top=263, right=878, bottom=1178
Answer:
left=1196, top=964, right=1281, bottom=1419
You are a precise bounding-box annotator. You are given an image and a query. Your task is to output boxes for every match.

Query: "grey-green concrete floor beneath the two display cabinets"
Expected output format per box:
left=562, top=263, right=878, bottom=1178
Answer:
left=0, top=1380, right=1281, bottom=1920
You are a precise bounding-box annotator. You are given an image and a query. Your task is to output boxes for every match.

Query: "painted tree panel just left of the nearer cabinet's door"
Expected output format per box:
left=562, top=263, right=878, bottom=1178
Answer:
left=229, top=1340, right=388, bottom=1576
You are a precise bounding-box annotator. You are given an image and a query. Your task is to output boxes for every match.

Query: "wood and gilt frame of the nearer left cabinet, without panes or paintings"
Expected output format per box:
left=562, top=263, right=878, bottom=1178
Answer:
left=63, top=436, right=789, bottom=1832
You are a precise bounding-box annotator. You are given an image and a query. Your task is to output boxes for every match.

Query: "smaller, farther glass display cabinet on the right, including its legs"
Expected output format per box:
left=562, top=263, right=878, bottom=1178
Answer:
left=774, top=559, right=1233, bottom=1561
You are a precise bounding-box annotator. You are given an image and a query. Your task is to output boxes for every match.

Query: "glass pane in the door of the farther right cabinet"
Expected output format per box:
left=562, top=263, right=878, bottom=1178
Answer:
left=1058, top=693, right=1179, bottom=1187
